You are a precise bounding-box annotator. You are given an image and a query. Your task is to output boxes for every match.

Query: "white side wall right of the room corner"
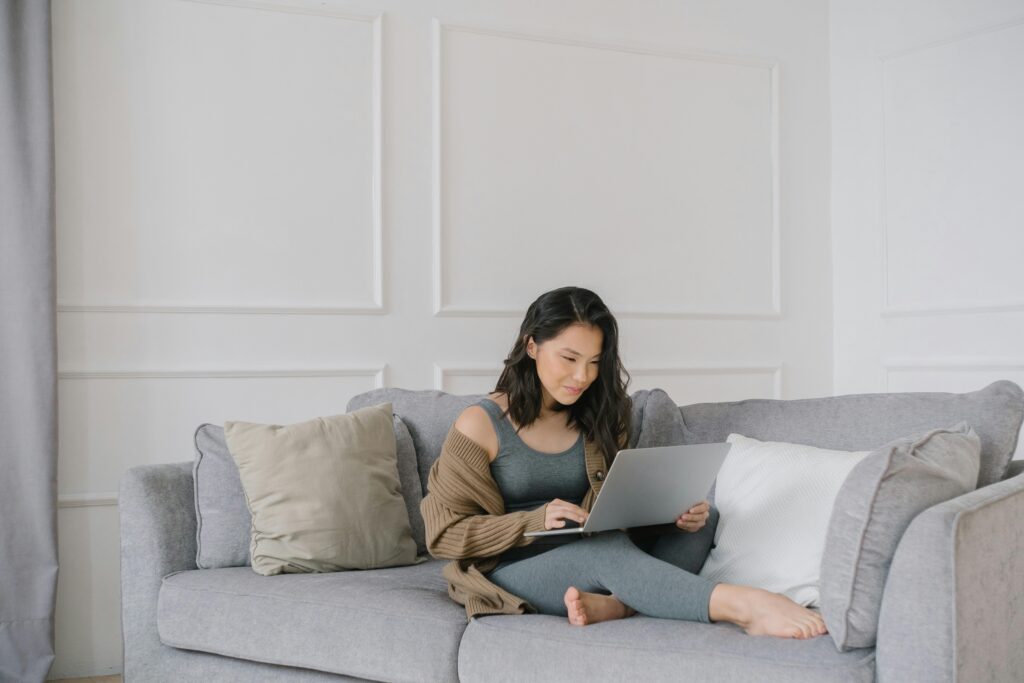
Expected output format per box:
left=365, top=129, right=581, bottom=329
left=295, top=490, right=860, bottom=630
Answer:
left=829, top=0, right=1024, bottom=409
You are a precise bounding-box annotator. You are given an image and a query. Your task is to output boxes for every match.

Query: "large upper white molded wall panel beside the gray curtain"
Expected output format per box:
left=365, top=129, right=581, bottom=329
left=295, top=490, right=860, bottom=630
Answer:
left=53, top=0, right=384, bottom=314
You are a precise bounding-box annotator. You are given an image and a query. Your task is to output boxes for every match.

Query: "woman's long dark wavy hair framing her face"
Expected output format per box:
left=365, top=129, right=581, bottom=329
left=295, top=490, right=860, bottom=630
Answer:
left=495, top=287, right=633, bottom=463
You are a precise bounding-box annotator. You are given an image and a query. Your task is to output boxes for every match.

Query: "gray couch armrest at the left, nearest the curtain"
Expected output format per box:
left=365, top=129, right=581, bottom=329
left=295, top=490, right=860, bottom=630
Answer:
left=118, top=461, right=196, bottom=681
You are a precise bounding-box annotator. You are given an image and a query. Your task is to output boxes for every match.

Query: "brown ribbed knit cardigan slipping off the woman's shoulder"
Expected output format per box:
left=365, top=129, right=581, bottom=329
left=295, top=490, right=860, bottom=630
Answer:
left=420, top=425, right=608, bottom=621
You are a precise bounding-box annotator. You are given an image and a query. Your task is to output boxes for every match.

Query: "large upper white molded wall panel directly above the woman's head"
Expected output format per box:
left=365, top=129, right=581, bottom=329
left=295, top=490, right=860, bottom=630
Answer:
left=433, top=22, right=781, bottom=319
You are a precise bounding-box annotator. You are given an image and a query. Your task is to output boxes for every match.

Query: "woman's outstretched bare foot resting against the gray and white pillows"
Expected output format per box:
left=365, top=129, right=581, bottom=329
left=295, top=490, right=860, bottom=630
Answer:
left=709, top=584, right=828, bottom=639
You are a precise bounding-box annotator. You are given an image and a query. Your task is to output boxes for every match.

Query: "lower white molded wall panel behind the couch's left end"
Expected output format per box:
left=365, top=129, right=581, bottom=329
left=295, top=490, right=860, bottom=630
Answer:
left=57, top=367, right=386, bottom=507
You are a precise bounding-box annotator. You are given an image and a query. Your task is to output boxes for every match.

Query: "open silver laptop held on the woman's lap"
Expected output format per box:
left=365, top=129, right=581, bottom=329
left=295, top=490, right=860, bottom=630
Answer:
left=524, top=443, right=732, bottom=536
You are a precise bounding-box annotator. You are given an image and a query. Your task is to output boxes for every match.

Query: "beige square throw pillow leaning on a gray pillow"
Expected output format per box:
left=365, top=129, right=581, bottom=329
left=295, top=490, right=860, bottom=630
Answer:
left=224, top=403, right=417, bottom=575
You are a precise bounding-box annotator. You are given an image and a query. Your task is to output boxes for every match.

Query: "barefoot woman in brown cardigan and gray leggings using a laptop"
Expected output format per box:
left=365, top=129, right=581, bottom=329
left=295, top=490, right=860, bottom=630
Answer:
left=421, top=287, right=825, bottom=638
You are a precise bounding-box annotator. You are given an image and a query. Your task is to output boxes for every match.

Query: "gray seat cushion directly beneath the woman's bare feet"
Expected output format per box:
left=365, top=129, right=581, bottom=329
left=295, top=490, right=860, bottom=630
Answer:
left=459, top=614, right=874, bottom=683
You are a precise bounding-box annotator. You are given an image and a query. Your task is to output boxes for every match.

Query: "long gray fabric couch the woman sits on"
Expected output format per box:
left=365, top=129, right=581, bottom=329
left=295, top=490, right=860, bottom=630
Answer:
left=120, top=381, right=1024, bottom=683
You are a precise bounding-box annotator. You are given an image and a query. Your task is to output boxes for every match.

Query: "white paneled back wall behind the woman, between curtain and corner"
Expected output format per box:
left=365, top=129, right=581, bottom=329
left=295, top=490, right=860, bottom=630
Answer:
left=52, top=0, right=833, bottom=678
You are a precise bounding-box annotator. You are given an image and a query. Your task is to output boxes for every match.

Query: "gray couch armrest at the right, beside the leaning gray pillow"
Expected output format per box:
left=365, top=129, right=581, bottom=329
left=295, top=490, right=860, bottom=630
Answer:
left=876, top=475, right=1024, bottom=683
